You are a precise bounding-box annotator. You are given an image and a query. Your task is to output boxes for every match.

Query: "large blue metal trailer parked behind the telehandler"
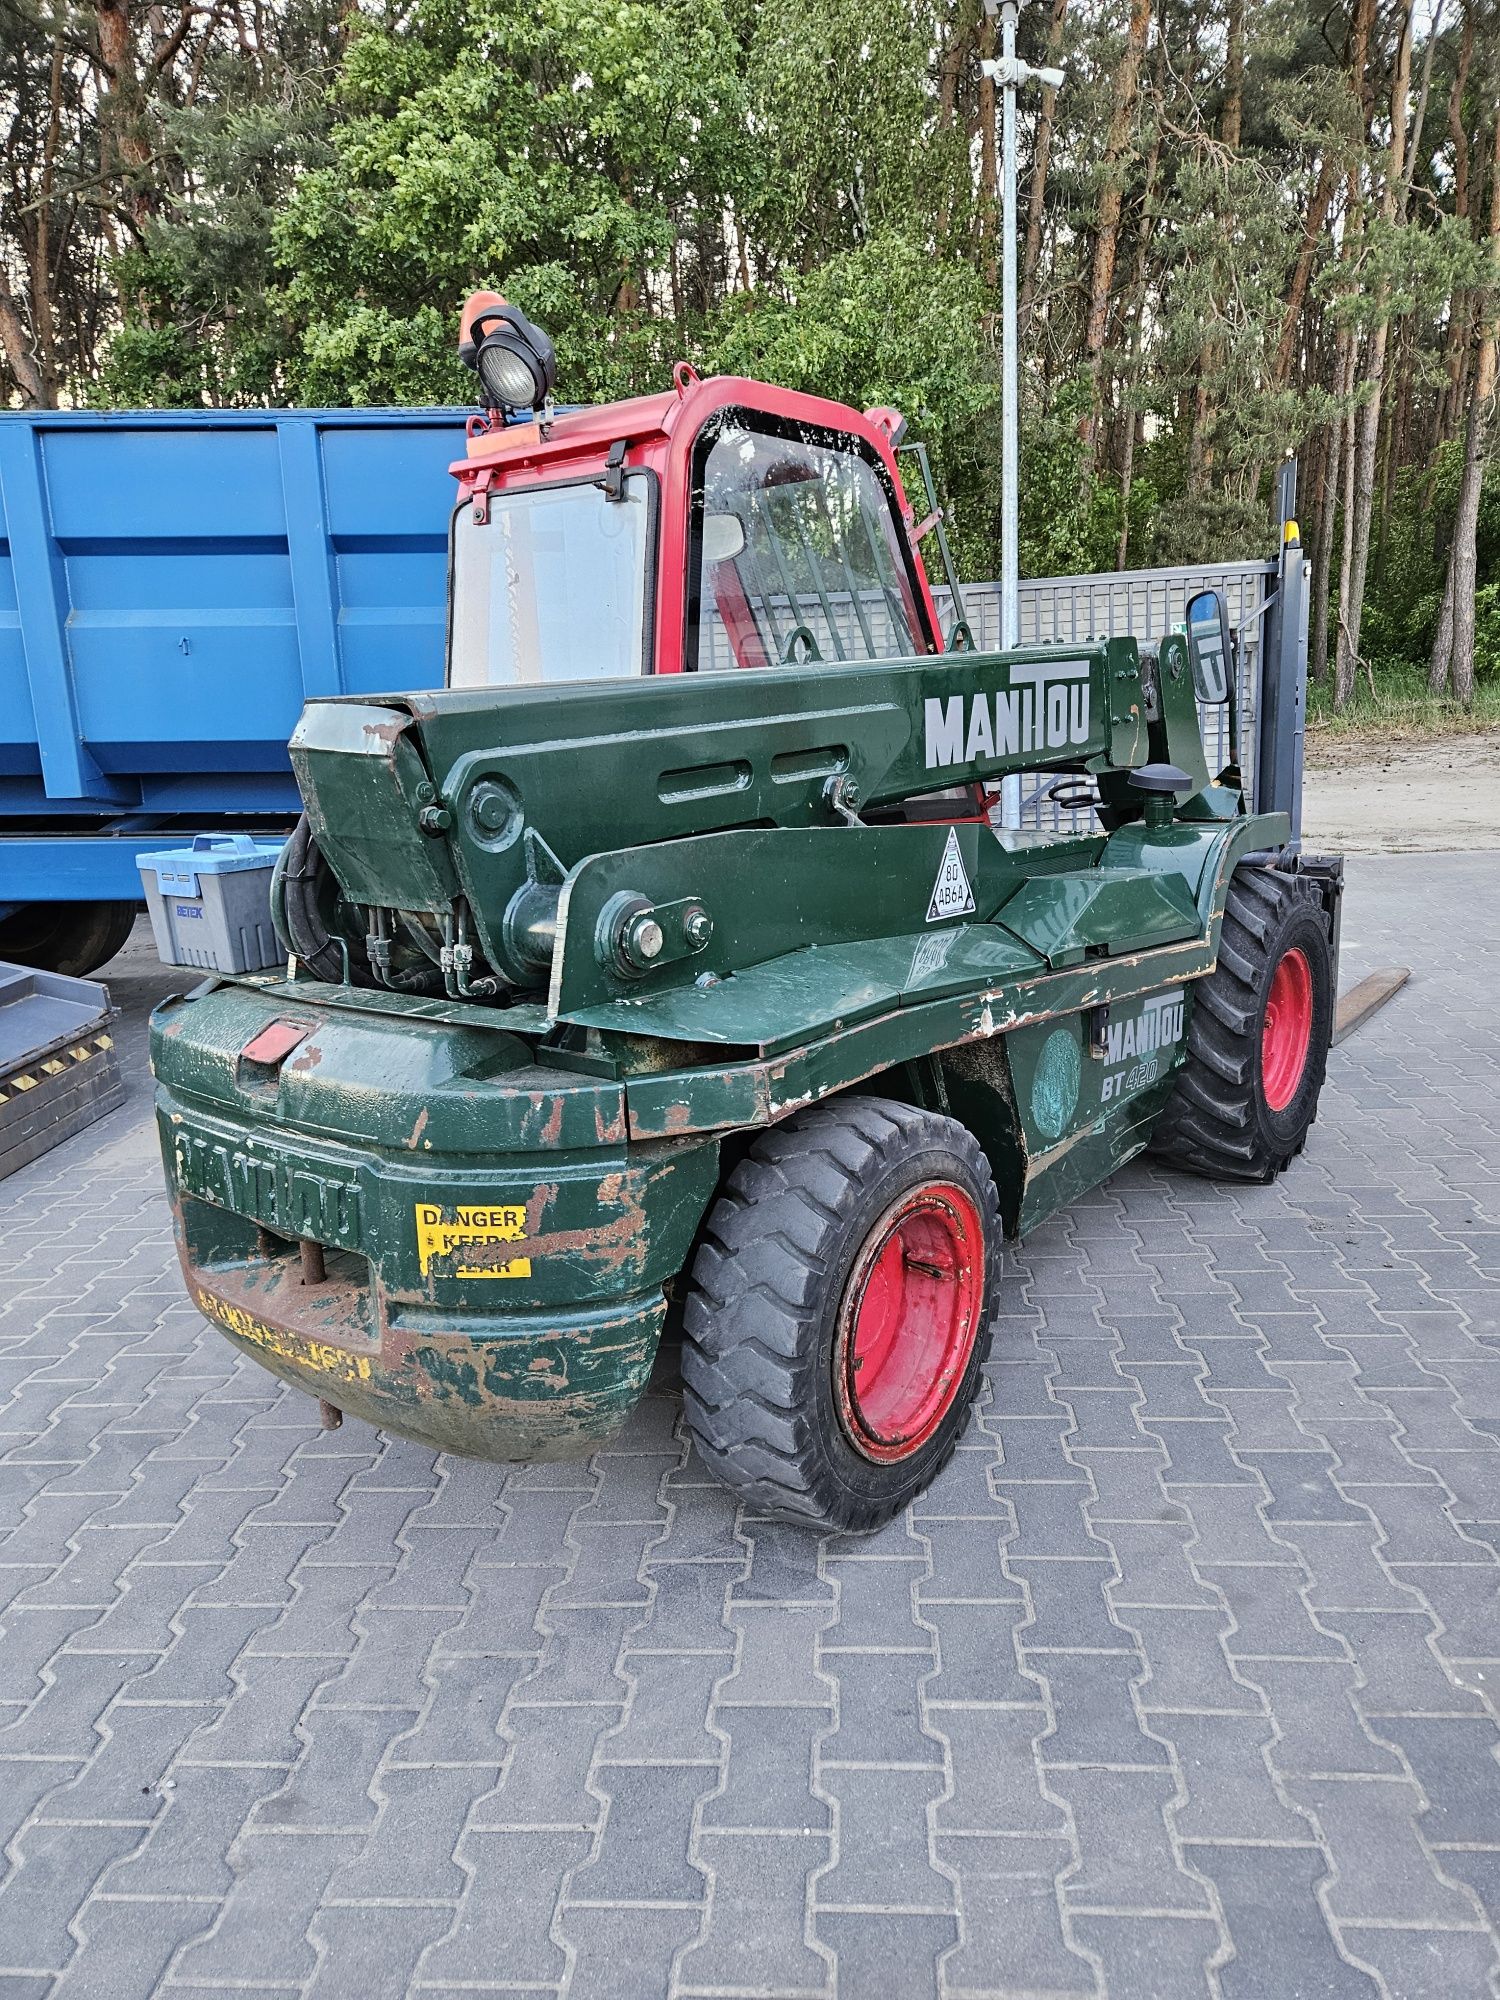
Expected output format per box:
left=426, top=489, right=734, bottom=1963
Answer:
left=0, top=410, right=466, bottom=972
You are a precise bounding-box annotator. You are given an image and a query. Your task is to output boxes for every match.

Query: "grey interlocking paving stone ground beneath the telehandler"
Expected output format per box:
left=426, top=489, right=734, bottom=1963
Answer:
left=0, top=854, right=1500, bottom=2000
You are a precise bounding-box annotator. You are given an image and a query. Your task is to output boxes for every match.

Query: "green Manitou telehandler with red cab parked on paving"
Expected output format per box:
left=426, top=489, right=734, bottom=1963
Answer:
left=152, top=296, right=1338, bottom=1530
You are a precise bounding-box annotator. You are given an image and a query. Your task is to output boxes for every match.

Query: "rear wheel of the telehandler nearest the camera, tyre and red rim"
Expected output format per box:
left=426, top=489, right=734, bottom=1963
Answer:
left=682, top=1096, right=1000, bottom=1532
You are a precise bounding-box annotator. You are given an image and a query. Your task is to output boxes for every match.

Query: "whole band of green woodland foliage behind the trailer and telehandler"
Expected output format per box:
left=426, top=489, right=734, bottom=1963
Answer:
left=0, top=0, right=1500, bottom=708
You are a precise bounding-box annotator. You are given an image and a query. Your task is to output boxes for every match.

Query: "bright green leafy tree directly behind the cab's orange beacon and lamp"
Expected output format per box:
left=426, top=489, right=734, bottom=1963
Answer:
left=272, top=0, right=742, bottom=402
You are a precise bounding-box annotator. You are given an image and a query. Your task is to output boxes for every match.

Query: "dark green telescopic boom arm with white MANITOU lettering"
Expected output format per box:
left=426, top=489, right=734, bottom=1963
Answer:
left=292, top=640, right=1196, bottom=990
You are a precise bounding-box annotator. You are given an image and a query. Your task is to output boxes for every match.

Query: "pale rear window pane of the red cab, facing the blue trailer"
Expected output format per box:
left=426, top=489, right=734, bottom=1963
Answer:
left=448, top=472, right=652, bottom=688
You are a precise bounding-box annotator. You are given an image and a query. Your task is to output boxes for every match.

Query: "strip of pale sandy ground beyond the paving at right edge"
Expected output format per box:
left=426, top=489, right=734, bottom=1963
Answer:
left=1302, top=730, right=1500, bottom=854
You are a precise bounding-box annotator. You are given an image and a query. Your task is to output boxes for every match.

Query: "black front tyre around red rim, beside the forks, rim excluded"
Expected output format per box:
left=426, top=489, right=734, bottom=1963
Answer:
left=1150, top=868, right=1334, bottom=1182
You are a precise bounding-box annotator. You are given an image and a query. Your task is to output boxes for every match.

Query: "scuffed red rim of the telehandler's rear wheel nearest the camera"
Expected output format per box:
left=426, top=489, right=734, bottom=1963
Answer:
left=834, top=1180, right=984, bottom=1462
